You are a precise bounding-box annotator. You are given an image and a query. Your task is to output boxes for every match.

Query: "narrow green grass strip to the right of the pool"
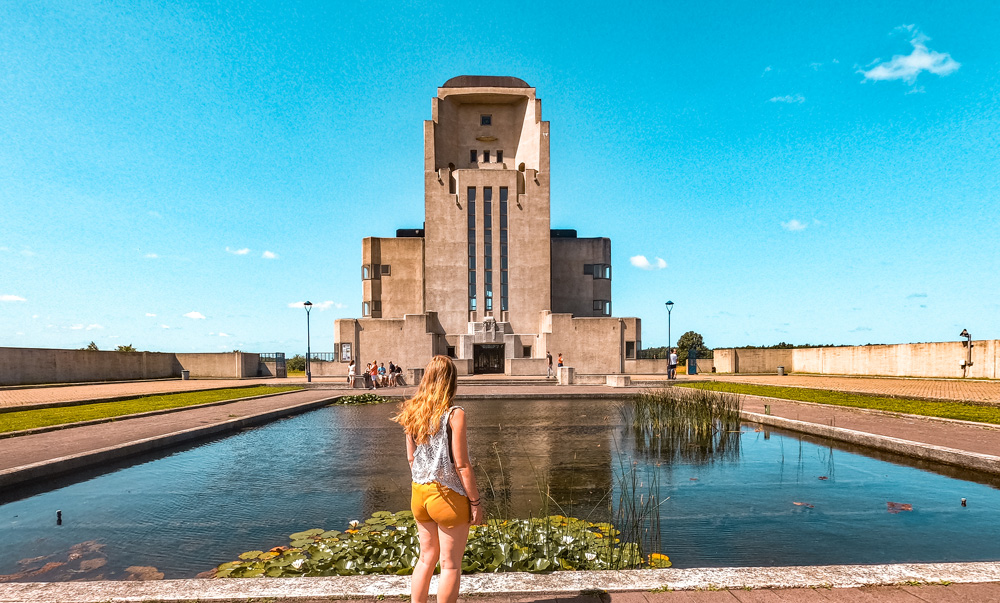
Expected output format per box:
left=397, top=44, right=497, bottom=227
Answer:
left=676, top=381, right=1000, bottom=425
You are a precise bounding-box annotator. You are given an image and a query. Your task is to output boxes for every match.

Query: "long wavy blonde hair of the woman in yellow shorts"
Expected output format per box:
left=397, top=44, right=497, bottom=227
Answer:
left=392, top=356, right=458, bottom=444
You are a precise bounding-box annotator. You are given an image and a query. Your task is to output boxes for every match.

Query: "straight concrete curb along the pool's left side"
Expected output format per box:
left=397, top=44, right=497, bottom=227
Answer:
left=0, top=396, right=341, bottom=490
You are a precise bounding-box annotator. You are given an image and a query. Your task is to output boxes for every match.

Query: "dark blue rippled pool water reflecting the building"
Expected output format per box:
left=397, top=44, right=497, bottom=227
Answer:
left=0, top=400, right=1000, bottom=581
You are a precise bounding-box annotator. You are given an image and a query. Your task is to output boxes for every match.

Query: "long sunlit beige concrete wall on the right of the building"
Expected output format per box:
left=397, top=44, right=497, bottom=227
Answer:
left=715, top=339, right=1000, bottom=379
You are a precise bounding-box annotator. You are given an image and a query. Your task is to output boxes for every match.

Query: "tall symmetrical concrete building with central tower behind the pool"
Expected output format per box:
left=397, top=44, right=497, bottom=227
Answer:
left=334, top=76, right=641, bottom=375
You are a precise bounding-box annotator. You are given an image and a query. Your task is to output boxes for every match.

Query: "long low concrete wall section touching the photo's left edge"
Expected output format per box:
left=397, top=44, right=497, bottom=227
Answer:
left=0, top=348, right=176, bottom=385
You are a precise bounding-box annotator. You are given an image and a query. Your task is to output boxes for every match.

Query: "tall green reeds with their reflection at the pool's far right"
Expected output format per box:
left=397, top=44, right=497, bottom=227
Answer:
left=620, top=389, right=742, bottom=462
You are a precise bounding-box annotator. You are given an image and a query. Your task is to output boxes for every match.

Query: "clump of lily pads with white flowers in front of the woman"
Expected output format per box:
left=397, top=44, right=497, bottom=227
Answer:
left=215, top=511, right=670, bottom=578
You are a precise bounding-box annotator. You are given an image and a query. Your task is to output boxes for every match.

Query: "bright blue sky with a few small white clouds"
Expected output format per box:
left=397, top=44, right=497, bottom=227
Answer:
left=0, top=1, right=1000, bottom=353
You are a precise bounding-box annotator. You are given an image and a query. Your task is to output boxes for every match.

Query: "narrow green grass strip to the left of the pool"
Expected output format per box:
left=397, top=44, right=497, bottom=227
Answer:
left=0, top=385, right=303, bottom=433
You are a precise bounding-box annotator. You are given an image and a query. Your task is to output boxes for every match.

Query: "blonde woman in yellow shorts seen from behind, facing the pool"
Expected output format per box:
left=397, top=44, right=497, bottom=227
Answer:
left=392, top=356, right=484, bottom=603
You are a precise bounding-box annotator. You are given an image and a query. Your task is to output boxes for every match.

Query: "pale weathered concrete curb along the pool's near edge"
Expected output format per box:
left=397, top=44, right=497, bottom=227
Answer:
left=0, top=562, right=1000, bottom=603
